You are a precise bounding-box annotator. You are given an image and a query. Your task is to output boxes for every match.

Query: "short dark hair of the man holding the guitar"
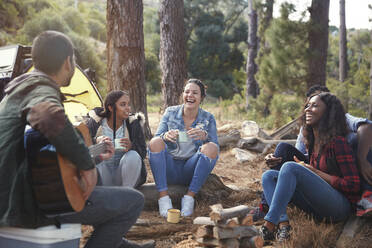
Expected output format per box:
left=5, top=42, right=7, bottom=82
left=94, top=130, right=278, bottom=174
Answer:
left=31, top=30, right=74, bottom=74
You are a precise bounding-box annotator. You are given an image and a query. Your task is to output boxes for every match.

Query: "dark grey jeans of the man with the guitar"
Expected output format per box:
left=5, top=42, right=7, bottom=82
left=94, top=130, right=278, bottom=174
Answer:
left=57, top=186, right=144, bottom=248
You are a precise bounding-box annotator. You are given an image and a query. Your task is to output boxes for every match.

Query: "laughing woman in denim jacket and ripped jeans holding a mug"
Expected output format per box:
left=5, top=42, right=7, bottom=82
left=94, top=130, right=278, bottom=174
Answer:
left=149, top=79, right=219, bottom=217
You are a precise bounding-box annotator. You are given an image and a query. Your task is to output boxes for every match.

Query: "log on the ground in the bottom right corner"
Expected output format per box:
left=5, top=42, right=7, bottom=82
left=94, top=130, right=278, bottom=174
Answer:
left=336, top=215, right=366, bottom=248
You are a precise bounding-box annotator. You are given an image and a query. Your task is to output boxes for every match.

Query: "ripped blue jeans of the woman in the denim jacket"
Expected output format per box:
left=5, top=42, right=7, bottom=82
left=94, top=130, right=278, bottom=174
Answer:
left=149, top=148, right=218, bottom=193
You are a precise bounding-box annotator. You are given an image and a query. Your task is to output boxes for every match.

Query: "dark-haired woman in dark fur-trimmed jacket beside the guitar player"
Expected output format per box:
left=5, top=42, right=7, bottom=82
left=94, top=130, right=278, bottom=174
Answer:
left=87, top=90, right=147, bottom=187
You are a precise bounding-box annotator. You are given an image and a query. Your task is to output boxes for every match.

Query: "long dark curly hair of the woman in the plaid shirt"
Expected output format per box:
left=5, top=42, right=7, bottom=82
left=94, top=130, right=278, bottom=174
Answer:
left=302, top=92, right=348, bottom=155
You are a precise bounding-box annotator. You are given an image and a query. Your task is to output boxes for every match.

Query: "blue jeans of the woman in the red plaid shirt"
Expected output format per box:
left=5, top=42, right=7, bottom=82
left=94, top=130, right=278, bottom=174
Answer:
left=262, top=162, right=352, bottom=224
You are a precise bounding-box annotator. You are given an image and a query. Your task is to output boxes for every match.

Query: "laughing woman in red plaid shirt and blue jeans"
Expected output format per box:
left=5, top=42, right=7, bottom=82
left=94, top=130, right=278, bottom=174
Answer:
left=261, top=92, right=360, bottom=241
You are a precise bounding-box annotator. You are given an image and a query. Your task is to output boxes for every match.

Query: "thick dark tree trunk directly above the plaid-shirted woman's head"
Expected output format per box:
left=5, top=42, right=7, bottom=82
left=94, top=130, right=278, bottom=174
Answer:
left=307, top=0, right=329, bottom=88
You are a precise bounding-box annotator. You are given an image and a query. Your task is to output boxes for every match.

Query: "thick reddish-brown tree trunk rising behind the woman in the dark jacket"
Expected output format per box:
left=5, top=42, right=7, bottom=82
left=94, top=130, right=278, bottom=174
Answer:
left=107, top=0, right=151, bottom=138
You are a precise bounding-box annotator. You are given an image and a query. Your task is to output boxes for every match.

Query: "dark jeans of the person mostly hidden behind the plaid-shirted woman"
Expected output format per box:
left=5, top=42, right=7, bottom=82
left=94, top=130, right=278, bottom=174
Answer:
left=261, top=142, right=308, bottom=205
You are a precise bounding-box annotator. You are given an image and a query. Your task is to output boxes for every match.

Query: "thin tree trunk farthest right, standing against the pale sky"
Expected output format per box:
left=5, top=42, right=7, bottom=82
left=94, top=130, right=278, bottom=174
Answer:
left=339, top=0, right=347, bottom=82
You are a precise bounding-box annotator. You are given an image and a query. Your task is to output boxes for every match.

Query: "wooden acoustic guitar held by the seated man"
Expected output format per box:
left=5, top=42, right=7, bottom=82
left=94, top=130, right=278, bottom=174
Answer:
left=25, top=123, right=107, bottom=215
